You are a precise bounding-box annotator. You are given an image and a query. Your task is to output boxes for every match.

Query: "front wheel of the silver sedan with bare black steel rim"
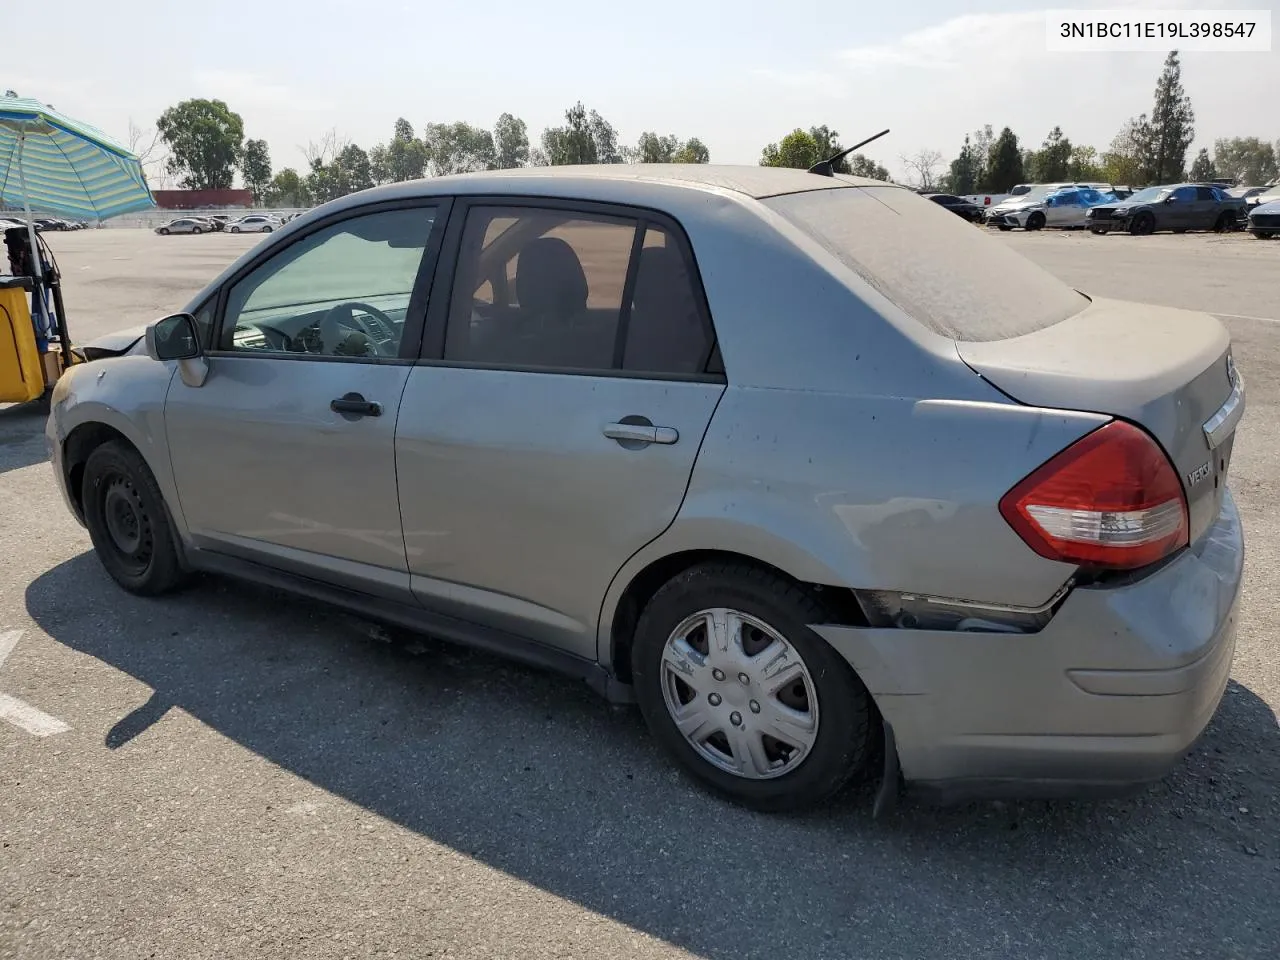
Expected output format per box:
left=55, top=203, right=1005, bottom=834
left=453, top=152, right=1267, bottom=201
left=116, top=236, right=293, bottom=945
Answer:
left=81, top=440, right=186, bottom=596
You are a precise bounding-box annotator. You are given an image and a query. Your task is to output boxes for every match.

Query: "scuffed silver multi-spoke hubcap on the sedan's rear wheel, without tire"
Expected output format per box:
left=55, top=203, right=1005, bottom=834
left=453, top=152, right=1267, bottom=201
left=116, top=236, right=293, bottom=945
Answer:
left=662, top=607, right=819, bottom=780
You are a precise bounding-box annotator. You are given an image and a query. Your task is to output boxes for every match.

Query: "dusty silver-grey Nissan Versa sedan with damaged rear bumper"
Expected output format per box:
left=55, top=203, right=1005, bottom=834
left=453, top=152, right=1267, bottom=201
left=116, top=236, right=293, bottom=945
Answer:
left=49, top=165, right=1244, bottom=810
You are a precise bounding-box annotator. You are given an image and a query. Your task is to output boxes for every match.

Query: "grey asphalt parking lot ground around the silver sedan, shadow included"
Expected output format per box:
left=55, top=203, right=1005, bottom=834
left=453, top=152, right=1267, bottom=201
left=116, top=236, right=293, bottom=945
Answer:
left=0, top=230, right=1280, bottom=960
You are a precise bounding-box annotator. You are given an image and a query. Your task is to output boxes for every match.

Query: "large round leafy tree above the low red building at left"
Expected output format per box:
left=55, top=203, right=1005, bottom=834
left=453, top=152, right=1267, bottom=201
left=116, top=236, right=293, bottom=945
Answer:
left=156, top=100, right=244, bottom=189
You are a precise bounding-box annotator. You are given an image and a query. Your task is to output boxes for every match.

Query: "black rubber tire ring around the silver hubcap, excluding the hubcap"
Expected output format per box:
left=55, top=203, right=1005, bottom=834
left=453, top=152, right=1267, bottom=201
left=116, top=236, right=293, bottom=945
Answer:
left=631, top=562, right=879, bottom=812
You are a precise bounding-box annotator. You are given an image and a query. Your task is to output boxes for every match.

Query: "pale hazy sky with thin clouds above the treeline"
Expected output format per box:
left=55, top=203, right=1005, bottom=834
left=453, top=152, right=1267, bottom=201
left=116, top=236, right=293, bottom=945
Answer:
left=0, top=0, right=1280, bottom=186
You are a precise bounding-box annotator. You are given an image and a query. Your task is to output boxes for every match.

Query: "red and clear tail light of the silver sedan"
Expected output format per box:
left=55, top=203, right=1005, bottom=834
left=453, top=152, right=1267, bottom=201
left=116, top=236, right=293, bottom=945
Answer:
left=1000, top=421, right=1188, bottom=570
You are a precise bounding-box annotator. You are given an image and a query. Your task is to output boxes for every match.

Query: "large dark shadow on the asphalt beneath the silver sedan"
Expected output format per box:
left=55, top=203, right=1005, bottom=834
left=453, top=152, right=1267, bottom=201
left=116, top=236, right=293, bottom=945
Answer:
left=26, top=554, right=1280, bottom=960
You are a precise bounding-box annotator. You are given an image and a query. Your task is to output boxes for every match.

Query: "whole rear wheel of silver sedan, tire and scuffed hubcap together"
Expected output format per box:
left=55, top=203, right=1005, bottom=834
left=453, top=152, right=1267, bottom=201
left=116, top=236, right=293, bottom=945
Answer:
left=631, top=563, right=877, bottom=810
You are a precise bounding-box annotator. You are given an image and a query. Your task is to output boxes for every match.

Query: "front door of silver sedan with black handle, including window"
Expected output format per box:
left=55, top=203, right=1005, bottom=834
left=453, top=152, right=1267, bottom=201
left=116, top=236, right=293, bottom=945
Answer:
left=164, top=204, right=443, bottom=599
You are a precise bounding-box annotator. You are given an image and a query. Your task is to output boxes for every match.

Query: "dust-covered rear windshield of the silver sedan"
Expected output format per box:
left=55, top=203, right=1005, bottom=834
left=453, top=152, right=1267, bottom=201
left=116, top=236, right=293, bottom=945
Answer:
left=763, top=187, right=1089, bottom=340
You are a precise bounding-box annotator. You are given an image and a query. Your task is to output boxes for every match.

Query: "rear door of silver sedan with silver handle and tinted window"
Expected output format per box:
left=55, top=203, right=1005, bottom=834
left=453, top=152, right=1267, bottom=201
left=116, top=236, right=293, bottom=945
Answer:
left=396, top=198, right=724, bottom=659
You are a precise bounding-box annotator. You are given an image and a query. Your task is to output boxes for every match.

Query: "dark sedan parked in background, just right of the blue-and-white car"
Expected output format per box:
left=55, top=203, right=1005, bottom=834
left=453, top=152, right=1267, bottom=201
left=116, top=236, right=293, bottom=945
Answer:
left=1085, top=183, right=1245, bottom=236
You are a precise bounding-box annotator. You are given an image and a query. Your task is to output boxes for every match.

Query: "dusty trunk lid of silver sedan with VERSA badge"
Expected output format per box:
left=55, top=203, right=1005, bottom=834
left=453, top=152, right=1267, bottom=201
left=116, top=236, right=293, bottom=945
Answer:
left=956, top=300, right=1244, bottom=552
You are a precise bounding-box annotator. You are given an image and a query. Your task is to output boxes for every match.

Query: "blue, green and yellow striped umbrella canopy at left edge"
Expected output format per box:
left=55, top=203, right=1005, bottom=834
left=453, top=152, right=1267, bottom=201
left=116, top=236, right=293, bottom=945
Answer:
left=0, top=97, right=155, bottom=220
